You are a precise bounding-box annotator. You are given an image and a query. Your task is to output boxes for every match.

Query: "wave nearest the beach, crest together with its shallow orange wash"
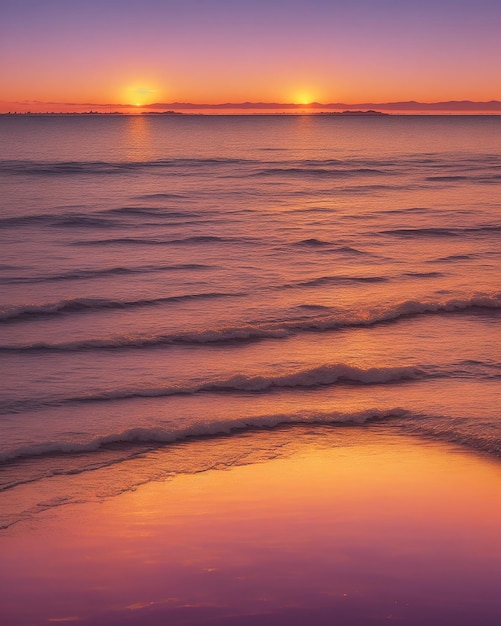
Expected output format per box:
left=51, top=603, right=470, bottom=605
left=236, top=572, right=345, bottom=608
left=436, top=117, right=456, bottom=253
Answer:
left=0, top=406, right=501, bottom=529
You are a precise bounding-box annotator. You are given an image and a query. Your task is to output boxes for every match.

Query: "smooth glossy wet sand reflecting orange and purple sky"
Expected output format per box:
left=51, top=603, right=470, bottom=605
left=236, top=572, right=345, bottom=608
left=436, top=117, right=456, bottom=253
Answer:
left=0, top=427, right=501, bottom=626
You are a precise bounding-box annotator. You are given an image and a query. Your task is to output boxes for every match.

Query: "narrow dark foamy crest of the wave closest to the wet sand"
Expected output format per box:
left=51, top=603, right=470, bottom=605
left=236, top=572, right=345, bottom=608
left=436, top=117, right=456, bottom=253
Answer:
left=0, top=407, right=408, bottom=464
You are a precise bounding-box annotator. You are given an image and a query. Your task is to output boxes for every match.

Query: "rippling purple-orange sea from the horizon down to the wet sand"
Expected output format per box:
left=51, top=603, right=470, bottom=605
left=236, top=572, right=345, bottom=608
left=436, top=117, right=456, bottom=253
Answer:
left=0, top=116, right=501, bottom=526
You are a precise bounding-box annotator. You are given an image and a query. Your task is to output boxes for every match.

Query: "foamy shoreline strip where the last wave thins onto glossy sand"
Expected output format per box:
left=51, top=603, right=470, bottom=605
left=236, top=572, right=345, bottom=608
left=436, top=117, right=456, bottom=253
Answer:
left=0, top=409, right=501, bottom=533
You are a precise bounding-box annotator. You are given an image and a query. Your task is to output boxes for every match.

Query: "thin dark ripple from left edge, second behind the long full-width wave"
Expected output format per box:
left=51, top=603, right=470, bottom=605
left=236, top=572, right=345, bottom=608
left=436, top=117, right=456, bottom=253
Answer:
left=0, top=263, right=214, bottom=284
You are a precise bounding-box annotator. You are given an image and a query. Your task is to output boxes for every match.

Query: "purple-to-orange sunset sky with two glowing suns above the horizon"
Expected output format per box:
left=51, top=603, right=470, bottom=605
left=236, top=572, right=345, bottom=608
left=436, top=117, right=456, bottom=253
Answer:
left=0, top=0, right=501, bottom=111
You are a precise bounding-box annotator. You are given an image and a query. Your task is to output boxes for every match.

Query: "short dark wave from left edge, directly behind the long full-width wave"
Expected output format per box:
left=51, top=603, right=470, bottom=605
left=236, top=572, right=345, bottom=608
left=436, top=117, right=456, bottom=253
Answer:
left=0, top=291, right=240, bottom=322
